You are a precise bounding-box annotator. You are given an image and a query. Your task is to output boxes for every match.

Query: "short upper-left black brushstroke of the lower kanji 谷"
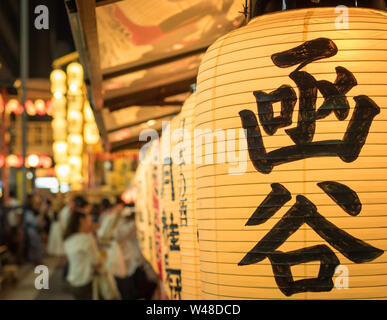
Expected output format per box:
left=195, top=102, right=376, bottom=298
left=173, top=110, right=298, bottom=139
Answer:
left=246, top=183, right=292, bottom=226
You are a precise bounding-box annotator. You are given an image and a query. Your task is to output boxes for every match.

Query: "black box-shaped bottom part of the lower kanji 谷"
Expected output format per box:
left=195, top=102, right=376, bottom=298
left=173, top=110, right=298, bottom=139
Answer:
left=268, top=245, right=340, bottom=297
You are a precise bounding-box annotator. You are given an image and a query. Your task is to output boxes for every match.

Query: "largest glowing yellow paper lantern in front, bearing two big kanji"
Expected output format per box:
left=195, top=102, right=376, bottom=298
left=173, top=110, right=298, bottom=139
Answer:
left=195, top=8, right=387, bottom=299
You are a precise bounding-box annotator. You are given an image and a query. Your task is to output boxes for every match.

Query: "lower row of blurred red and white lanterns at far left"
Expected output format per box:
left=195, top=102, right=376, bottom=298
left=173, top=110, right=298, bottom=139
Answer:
left=0, top=154, right=52, bottom=169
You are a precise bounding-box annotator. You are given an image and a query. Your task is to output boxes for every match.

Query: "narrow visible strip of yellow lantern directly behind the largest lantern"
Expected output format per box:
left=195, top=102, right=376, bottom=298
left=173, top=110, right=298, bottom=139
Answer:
left=179, top=94, right=201, bottom=300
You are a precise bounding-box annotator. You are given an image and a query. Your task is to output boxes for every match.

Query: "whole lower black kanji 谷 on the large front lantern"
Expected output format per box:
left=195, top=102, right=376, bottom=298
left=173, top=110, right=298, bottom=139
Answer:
left=239, top=181, right=384, bottom=296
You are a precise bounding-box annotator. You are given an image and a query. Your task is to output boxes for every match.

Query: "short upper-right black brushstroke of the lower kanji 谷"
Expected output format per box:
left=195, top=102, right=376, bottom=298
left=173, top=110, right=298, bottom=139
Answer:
left=317, top=181, right=362, bottom=216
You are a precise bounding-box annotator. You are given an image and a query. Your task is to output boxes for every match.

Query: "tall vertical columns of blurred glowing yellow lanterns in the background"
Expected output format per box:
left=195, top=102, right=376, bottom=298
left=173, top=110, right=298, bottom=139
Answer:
left=50, top=62, right=99, bottom=190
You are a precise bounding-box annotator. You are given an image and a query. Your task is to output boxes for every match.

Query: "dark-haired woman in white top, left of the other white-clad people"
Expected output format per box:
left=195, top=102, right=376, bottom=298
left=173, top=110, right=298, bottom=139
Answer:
left=64, top=210, right=101, bottom=300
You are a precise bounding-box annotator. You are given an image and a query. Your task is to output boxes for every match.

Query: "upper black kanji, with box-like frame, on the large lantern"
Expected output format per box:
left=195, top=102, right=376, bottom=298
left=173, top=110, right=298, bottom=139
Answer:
left=239, top=38, right=380, bottom=173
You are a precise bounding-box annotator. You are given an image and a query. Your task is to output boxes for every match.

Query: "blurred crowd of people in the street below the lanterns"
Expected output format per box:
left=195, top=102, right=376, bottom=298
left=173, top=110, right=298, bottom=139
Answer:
left=0, top=193, right=160, bottom=300
